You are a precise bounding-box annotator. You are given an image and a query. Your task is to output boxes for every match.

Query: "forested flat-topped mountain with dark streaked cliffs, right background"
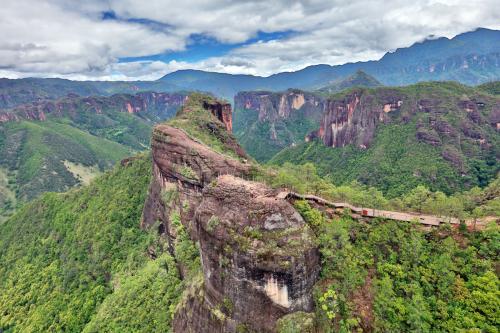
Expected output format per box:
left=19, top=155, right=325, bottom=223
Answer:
left=271, top=82, right=500, bottom=197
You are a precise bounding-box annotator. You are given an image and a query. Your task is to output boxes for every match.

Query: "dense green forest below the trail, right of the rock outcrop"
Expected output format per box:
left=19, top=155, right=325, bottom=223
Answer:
left=296, top=201, right=500, bottom=332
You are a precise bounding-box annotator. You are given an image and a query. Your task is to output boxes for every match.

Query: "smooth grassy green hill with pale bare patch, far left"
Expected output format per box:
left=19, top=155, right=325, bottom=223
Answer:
left=0, top=121, right=132, bottom=214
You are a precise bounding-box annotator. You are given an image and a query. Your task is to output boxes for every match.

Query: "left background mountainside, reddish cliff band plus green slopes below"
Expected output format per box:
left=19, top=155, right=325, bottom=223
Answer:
left=0, top=93, right=186, bottom=216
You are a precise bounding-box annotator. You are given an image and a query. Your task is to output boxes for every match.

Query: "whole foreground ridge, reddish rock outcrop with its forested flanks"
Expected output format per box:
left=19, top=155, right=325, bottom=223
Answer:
left=0, top=96, right=500, bottom=333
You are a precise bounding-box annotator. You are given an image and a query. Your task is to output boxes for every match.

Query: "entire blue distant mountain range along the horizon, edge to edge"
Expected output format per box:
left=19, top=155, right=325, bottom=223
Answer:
left=0, top=28, right=500, bottom=104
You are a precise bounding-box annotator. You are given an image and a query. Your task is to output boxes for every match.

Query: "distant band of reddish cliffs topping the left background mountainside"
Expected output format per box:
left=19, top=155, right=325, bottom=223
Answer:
left=0, top=92, right=187, bottom=122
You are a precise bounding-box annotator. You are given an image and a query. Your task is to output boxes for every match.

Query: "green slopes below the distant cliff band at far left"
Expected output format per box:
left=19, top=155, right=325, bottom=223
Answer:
left=0, top=103, right=158, bottom=219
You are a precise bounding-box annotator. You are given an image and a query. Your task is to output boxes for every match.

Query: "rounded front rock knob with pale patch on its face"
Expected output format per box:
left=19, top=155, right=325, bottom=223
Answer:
left=174, top=175, right=319, bottom=332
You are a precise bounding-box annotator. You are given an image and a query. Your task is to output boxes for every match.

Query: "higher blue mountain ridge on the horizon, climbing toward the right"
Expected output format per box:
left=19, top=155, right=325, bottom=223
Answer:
left=160, top=28, right=500, bottom=98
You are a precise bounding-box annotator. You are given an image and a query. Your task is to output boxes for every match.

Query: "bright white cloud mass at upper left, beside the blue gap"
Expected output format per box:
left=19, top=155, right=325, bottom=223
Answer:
left=0, top=0, right=185, bottom=74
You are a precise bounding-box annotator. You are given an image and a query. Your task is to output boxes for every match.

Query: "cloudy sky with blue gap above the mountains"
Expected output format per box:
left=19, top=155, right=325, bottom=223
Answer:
left=0, top=0, right=500, bottom=80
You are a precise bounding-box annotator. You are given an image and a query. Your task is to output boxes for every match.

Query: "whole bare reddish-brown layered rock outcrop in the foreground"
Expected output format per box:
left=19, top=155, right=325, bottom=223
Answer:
left=142, top=97, right=319, bottom=332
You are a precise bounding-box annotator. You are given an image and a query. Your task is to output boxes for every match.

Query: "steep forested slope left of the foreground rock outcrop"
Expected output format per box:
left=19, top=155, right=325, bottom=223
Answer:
left=0, top=156, right=180, bottom=332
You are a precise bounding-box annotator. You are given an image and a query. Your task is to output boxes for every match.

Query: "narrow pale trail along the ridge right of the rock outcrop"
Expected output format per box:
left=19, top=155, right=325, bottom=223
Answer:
left=277, top=191, right=498, bottom=227
